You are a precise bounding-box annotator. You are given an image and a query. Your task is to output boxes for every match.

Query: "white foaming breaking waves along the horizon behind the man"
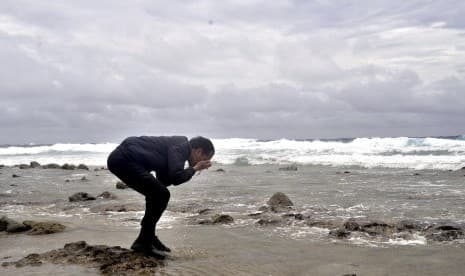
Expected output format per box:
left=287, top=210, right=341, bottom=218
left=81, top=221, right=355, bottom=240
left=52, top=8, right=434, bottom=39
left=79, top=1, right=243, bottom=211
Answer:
left=0, top=135, right=465, bottom=170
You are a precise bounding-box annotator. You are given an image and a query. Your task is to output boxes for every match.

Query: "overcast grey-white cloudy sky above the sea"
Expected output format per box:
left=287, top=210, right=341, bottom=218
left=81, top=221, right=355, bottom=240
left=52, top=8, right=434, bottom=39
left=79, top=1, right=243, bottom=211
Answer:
left=0, top=0, right=465, bottom=144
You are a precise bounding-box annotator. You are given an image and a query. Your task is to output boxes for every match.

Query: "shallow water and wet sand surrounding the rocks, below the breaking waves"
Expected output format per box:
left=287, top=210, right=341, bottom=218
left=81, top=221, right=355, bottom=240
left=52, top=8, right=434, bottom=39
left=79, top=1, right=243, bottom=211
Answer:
left=0, top=165, right=465, bottom=275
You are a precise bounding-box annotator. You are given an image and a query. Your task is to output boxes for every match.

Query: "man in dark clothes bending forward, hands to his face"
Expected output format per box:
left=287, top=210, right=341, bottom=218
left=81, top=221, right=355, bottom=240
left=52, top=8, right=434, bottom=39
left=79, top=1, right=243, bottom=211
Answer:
left=107, top=136, right=215, bottom=259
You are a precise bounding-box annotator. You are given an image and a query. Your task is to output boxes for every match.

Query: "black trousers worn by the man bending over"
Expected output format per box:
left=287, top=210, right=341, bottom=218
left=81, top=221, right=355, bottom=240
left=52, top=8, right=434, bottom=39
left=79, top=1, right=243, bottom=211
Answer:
left=107, top=147, right=170, bottom=239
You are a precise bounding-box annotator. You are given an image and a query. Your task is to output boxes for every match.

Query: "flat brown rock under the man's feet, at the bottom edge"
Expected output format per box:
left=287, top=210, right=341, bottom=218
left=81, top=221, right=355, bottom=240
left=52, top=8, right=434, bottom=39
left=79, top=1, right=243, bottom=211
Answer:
left=2, top=241, right=162, bottom=275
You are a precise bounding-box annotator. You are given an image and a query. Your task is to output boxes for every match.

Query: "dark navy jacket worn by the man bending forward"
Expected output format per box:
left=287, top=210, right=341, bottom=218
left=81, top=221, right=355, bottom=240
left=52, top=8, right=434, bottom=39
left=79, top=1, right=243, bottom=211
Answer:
left=119, top=136, right=195, bottom=186
